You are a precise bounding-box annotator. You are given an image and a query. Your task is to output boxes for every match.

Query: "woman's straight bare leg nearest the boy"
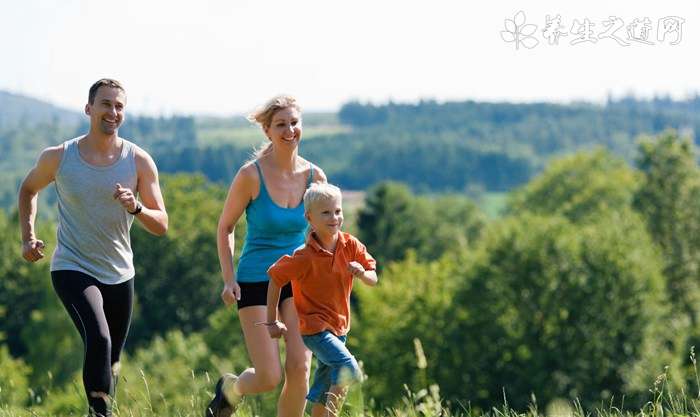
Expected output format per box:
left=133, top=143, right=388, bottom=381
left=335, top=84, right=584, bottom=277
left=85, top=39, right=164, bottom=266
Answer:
left=277, top=298, right=311, bottom=417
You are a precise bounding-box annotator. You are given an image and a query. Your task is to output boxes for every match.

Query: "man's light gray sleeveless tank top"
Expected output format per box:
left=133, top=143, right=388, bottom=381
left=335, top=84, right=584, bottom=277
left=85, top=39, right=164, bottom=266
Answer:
left=51, top=138, right=137, bottom=284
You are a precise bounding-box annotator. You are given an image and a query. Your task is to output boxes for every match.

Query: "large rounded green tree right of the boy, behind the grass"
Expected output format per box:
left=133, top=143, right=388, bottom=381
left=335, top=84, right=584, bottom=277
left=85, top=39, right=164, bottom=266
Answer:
left=446, top=210, right=682, bottom=408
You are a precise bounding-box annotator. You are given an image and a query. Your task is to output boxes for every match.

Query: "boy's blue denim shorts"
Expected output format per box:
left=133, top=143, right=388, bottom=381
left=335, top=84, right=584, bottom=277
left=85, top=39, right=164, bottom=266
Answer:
left=302, top=330, right=362, bottom=404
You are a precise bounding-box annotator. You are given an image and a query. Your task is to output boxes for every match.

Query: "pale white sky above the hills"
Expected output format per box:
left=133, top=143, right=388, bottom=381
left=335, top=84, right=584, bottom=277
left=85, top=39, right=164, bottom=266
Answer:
left=0, top=0, right=700, bottom=116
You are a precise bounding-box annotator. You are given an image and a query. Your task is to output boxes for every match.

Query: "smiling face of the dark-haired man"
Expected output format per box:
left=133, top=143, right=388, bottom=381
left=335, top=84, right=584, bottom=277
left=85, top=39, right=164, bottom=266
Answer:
left=85, top=86, right=126, bottom=135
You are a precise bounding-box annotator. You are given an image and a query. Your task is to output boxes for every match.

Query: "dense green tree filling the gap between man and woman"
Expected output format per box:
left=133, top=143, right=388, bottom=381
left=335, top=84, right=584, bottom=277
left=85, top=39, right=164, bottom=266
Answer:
left=131, top=175, right=245, bottom=346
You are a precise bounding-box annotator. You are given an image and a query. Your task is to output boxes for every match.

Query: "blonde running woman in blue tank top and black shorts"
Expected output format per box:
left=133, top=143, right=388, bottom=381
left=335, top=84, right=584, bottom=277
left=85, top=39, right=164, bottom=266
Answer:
left=205, top=96, right=326, bottom=417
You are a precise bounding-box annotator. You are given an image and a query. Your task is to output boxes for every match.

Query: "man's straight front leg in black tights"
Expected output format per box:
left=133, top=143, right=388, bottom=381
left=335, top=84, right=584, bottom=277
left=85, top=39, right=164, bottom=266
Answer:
left=51, top=271, right=112, bottom=417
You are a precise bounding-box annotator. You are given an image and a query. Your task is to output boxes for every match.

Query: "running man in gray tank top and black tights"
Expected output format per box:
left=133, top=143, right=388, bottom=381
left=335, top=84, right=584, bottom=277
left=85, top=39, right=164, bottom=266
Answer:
left=19, top=79, right=168, bottom=417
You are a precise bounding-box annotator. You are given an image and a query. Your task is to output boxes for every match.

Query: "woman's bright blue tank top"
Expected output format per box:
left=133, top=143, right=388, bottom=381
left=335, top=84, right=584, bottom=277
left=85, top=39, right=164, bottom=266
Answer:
left=236, top=161, right=314, bottom=282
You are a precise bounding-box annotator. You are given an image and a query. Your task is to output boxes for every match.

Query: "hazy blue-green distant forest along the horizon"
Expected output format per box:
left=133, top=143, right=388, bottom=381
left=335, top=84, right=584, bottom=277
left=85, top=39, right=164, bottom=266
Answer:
left=0, top=91, right=700, bottom=207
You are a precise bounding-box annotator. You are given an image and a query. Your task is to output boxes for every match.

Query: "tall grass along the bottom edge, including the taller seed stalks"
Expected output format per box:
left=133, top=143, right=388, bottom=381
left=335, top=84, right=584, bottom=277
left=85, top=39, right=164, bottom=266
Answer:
left=0, top=339, right=700, bottom=417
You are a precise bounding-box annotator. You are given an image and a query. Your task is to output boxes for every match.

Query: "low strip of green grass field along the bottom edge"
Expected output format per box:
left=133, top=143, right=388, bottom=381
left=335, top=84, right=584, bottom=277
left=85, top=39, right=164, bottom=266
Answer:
left=5, top=379, right=700, bottom=417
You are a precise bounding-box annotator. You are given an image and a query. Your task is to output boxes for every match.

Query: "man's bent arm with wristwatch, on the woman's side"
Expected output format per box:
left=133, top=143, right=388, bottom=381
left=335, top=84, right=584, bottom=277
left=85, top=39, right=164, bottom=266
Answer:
left=124, top=148, right=168, bottom=236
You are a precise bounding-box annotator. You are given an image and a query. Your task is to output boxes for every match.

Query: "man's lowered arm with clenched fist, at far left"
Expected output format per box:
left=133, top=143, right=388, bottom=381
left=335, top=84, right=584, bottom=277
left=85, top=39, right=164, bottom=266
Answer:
left=18, top=145, right=63, bottom=262
